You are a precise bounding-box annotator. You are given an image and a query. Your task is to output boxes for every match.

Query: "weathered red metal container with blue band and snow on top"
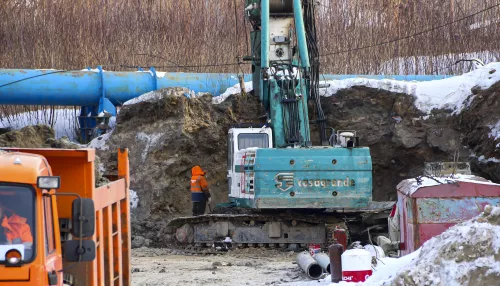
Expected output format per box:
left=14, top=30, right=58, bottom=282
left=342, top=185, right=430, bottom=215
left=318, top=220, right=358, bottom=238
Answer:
left=397, top=175, right=500, bottom=256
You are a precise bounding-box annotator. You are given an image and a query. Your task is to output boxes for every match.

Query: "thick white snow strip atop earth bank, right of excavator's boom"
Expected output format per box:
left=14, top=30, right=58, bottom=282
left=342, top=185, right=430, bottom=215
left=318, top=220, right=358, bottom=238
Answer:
left=320, top=62, right=500, bottom=113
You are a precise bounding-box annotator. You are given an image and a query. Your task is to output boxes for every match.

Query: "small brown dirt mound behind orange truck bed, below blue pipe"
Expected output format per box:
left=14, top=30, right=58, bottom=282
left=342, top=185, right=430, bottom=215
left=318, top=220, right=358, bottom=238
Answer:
left=0, top=125, right=55, bottom=148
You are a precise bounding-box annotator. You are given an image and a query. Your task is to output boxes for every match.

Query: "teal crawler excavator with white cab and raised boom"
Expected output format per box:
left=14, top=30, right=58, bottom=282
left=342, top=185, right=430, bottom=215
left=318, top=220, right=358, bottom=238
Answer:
left=169, top=0, right=393, bottom=247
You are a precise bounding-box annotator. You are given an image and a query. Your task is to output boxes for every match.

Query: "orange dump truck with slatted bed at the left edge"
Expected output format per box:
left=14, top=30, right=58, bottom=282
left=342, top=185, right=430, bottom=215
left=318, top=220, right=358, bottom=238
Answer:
left=0, top=148, right=131, bottom=286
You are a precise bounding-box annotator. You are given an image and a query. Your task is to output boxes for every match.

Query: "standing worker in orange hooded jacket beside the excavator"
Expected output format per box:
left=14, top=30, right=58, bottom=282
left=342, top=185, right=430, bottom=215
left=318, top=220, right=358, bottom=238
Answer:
left=191, top=166, right=211, bottom=216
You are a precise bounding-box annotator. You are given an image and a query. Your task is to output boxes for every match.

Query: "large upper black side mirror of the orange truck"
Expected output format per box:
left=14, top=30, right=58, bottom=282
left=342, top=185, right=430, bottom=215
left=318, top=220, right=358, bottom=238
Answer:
left=71, top=198, right=95, bottom=237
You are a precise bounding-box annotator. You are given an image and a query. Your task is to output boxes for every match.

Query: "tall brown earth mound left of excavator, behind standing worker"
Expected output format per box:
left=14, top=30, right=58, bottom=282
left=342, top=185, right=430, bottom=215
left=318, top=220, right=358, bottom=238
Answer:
left=90, top=88, right=264, bottom=226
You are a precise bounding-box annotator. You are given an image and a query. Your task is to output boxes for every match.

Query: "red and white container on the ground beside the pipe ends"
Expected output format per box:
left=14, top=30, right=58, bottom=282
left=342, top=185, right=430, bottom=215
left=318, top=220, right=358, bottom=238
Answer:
left=341, top=249, right=372, bottom=282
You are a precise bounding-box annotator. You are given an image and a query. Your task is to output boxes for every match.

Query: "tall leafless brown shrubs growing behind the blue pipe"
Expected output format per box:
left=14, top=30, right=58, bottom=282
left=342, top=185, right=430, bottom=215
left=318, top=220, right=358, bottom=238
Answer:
left=0, top=0, right=500, bottom=118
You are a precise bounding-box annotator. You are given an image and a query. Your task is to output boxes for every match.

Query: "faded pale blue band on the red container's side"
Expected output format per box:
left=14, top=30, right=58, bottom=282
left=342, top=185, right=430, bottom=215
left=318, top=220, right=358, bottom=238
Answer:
left=416, top=197, right=500, bottom=223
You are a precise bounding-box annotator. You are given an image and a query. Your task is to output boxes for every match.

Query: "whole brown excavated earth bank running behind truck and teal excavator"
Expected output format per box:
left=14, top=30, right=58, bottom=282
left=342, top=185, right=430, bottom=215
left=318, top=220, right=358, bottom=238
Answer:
left=0, top=83, right=500, bottom=247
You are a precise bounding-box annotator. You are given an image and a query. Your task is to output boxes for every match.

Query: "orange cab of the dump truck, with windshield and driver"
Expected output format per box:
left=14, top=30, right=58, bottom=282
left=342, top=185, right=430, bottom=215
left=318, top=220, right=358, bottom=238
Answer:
left=0, top=151, right=62, bottom=285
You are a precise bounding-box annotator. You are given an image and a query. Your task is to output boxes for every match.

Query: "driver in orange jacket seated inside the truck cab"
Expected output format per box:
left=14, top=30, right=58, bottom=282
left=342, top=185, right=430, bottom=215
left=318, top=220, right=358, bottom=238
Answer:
left=0, top=203, right=33, bottom=248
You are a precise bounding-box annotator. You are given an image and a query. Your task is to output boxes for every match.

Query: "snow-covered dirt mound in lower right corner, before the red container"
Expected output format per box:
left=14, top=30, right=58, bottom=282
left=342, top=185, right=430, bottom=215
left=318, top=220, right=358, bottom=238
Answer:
left=390, top=206, right=500, bottom=286
